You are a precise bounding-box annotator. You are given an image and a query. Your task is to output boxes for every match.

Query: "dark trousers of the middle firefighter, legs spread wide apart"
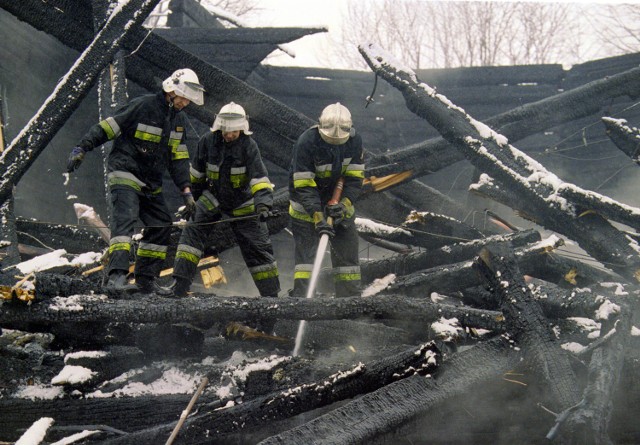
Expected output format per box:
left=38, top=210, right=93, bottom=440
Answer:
left=173, top=205, right=280, bottom=297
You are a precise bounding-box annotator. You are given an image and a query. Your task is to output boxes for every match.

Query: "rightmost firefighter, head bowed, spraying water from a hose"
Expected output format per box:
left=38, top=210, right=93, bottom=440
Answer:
left=289, top=102, right=364, bottom=298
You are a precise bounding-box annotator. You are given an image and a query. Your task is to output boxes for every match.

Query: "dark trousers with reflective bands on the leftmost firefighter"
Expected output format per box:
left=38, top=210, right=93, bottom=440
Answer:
left=107, top=187, right=172, bottom=278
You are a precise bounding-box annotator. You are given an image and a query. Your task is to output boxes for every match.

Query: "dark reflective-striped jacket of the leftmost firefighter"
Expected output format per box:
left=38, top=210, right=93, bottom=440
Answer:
left=80, top=92, right=191, bottom=193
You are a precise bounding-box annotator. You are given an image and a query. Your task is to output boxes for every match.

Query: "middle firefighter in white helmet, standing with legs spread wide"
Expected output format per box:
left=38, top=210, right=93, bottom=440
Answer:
left=162, top=102, right=280, bottom=297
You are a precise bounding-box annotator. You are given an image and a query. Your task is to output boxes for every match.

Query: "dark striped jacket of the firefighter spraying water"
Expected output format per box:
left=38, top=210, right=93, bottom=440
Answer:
left=289, top=126, right=364, bottom=222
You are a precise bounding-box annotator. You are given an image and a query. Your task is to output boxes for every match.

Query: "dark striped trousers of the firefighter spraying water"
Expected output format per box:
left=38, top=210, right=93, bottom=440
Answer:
left=291, top=217, right=360, bottom=298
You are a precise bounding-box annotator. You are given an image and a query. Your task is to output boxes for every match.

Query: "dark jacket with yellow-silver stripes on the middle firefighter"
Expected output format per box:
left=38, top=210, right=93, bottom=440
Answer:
left=191, top=131, right=273, bottom=216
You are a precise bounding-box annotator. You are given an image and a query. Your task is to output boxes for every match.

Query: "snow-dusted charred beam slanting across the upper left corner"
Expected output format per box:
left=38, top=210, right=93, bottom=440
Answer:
left=0, top=0, right=159, bottom=206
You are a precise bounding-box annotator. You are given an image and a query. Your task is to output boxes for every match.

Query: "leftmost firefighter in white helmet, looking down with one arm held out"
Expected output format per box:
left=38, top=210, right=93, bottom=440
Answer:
left=67, top=68, right=204, bottom=292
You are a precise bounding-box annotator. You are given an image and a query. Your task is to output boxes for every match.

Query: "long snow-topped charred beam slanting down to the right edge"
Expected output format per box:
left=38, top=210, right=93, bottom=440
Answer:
left=359, top=44, right=640, bottom=281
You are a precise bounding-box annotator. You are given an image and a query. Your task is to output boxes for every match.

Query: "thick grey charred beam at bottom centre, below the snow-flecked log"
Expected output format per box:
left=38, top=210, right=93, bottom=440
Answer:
left=260, top=338, right=520, bottom=445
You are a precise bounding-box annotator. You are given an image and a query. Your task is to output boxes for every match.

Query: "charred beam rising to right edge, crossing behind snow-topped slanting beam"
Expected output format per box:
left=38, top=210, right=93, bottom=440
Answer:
left=368, top=63, right=640, bottom=177
